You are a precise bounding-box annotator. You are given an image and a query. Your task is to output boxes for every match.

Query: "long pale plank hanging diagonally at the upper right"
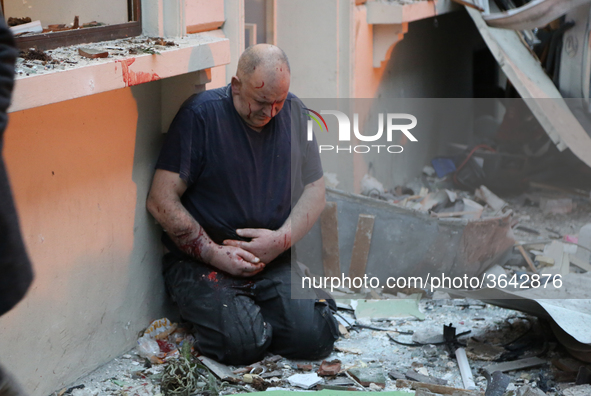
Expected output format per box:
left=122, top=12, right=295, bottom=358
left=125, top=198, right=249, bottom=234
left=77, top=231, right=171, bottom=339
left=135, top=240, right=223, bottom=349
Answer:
left=466, top=8, right=591, bottom=166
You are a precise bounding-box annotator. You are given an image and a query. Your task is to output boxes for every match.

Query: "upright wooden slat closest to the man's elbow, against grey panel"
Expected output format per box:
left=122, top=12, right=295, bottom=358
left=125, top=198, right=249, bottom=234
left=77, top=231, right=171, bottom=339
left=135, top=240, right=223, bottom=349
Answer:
left=320, top=202, right=341, bottom=277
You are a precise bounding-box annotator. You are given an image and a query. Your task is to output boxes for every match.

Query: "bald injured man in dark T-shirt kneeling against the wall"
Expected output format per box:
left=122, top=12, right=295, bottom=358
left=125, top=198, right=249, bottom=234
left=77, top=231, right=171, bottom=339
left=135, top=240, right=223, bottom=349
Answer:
left=147, top=44, right=338, bottom=365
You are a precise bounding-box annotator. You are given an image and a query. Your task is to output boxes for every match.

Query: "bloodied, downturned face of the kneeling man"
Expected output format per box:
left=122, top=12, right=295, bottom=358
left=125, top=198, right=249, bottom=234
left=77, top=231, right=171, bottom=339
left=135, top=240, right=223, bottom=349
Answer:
left=232, top=66, right=290, bottom=130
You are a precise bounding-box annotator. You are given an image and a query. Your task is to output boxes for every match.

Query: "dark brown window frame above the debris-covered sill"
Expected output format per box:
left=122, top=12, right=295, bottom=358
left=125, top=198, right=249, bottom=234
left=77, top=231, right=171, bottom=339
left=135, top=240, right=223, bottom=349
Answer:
left=0, top=0, right=142, bottom=51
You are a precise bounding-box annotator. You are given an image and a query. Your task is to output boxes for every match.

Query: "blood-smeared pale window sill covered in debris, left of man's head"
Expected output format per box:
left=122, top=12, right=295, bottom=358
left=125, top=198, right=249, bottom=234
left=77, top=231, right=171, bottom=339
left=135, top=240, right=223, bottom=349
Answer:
left=8, top=30, right=230, bottom=112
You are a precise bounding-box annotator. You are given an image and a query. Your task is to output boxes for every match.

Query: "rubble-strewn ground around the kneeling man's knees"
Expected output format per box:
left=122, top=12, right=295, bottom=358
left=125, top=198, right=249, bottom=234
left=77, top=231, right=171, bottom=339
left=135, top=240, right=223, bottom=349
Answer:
left=55, top=292, right=591, bottom=396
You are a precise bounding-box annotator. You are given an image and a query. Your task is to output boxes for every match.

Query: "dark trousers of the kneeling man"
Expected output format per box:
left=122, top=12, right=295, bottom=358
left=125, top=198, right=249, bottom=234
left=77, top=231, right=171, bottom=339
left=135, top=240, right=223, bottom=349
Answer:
left=163, top=253, right=338, bottom=365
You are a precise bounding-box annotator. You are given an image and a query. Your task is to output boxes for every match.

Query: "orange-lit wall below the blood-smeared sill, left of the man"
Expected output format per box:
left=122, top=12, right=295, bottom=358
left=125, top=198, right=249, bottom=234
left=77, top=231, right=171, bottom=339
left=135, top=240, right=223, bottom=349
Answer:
left=0, top=82, right=171, bottom=396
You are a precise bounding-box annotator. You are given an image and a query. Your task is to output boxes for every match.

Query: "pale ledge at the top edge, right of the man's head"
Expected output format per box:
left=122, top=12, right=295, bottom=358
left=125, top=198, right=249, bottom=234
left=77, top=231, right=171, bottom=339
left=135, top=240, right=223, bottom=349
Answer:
left=365, top=0, right=460, bottom=25
